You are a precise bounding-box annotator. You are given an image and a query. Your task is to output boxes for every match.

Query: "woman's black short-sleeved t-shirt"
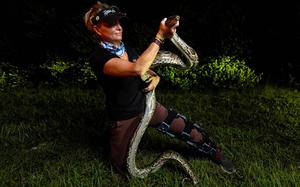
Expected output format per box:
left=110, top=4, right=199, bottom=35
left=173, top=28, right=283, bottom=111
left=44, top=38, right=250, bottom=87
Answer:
left=90, top=47, right=145, bottom=120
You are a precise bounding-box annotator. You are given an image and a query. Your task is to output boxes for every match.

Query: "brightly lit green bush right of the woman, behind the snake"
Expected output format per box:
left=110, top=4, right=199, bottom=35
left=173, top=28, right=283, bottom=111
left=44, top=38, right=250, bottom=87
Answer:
left=157, top=56, right=262, bottom=89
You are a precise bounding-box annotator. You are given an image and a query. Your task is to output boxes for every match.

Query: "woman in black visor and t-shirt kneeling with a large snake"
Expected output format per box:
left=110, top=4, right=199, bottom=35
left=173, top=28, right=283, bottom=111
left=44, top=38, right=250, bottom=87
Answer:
left=84, top=2, right=235, bottom=173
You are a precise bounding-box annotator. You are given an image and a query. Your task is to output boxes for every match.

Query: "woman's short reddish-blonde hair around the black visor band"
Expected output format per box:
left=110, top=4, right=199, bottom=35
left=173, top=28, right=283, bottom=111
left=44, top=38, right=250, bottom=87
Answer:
left=83, top=1, right=110, bottom=32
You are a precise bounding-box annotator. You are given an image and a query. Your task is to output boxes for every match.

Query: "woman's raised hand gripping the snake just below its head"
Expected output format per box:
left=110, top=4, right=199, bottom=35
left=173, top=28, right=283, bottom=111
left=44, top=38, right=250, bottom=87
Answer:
left=156, top=18, right=179, bottom=40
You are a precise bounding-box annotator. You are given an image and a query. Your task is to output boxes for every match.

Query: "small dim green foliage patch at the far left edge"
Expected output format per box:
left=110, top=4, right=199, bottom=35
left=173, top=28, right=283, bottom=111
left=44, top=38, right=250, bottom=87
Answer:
left=0, top=62, right=27, bottom=91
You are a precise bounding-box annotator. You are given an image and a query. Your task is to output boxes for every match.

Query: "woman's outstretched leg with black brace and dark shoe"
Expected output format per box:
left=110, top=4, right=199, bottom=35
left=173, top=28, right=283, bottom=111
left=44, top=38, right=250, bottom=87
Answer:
left=150, top=103, right=235, bottom=173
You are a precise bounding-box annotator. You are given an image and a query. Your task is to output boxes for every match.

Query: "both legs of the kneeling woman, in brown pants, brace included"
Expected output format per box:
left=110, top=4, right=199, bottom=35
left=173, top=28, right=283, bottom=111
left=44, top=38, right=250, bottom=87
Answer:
left=110, top=103, right=234, bottom=173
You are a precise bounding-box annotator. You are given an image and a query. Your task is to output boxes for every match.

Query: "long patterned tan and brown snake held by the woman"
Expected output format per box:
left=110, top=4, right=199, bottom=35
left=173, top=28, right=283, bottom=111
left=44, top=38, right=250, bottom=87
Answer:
left=127, top=16, right=198, bottom=184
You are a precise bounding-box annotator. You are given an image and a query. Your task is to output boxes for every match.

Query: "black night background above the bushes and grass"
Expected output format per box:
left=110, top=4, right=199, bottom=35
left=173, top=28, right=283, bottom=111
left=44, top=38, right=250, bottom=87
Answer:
left=0, top=0, right=300, bottom=86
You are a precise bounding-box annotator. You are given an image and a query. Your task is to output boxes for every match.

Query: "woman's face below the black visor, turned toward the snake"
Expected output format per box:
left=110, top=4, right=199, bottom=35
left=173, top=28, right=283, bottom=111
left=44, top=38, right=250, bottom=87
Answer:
left=97, top=21, right=123, bottom=44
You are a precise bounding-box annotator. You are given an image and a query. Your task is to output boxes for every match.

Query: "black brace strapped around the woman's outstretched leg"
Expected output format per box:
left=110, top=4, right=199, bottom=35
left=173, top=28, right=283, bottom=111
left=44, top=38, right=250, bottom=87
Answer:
left=156, top=110, right=216, bottom=157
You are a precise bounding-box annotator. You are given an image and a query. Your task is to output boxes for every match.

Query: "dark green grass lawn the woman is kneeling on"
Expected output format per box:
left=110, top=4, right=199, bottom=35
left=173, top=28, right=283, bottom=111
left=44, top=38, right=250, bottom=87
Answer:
left=0, top=87, right=300, bottom=187
